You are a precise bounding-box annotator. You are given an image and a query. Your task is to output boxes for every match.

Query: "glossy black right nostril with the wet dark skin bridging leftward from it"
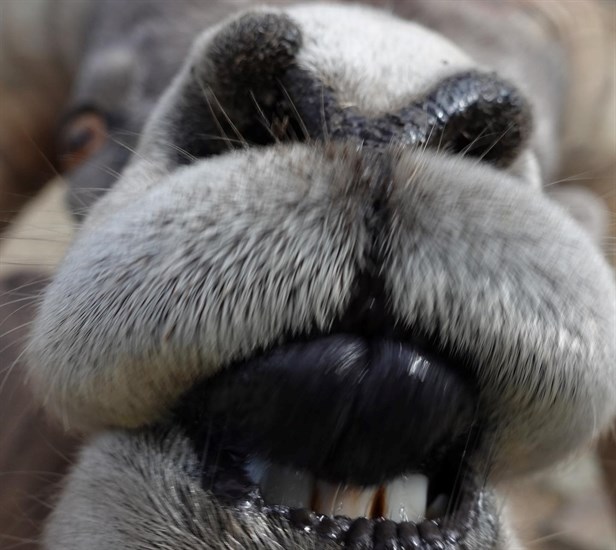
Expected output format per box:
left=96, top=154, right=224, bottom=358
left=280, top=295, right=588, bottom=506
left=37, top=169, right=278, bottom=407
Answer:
left=287, top=69, right=532, bottom=167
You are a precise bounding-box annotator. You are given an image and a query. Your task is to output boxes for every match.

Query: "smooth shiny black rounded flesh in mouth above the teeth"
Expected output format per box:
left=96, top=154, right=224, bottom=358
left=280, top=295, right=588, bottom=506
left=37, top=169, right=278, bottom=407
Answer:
left=177, top=335, right=476, bottom=485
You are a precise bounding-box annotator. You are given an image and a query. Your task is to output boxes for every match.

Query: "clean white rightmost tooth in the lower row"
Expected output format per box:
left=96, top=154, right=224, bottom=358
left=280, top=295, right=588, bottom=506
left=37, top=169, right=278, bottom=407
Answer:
left=385, top=474, right=428, bottom=522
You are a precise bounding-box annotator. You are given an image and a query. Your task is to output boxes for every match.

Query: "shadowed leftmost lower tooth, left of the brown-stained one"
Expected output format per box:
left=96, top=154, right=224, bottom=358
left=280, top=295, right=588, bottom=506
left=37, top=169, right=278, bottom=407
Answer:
left=261, top=465, right=314, bottom=508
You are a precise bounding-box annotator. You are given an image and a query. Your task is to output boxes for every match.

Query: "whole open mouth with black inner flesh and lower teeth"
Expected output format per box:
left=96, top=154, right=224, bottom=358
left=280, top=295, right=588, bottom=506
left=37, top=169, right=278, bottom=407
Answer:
left=177, top=334, right=483, bottom=550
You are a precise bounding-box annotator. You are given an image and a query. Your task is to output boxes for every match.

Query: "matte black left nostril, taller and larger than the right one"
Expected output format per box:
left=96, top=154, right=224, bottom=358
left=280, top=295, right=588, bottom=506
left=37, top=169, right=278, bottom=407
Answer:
left=169, top=12, right=302, bottom=164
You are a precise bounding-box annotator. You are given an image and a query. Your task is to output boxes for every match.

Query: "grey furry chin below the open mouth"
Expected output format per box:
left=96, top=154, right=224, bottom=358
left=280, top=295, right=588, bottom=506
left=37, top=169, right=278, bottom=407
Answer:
left=47, top=431, right=505, bottom=550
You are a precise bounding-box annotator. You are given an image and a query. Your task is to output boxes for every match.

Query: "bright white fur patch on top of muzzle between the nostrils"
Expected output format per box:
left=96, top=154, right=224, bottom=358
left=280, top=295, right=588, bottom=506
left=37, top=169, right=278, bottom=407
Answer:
left=288, top=4, right=477, bottom=116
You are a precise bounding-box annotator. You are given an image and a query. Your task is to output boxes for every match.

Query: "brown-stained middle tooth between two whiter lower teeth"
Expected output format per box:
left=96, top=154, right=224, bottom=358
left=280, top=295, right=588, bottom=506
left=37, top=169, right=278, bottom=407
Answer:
left=314, top=481, right=377, bottom=519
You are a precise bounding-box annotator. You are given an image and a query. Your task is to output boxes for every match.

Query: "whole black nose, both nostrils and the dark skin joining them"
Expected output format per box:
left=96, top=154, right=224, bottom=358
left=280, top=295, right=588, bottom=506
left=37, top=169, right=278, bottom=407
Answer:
left=167, top=13, right=531, bottom=166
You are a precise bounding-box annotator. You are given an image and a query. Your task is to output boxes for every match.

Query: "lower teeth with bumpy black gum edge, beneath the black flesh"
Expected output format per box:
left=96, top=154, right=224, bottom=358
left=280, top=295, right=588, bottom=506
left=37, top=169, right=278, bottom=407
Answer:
left=202, top=446, right=482, bottom=550
